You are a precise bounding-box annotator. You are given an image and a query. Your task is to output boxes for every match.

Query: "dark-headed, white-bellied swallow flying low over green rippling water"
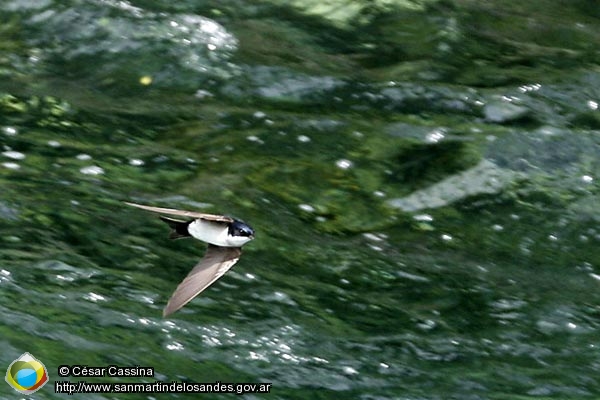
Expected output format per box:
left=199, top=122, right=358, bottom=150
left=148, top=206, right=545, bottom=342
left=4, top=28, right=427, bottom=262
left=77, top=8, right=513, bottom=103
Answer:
left=125, top=202, right=254, bottom=317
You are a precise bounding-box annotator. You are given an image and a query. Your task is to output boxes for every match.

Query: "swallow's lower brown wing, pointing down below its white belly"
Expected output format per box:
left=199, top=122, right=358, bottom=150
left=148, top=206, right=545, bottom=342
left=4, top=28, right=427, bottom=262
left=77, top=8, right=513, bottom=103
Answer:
left=163, top=244, right=242, bottom=317
